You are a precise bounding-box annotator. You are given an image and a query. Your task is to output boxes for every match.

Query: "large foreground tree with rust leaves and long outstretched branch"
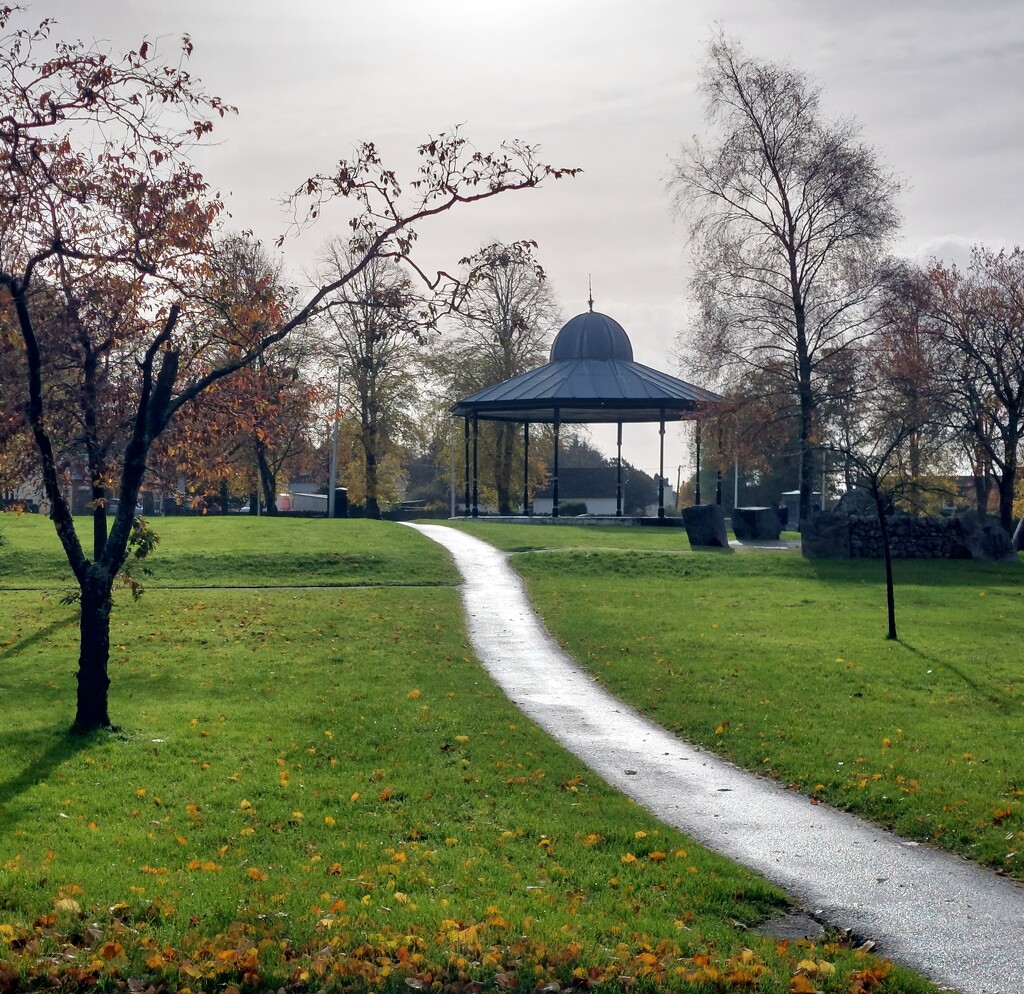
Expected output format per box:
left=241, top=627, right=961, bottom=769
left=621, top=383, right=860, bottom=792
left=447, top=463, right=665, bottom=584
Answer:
left=0, top=7, right=574, bottom=733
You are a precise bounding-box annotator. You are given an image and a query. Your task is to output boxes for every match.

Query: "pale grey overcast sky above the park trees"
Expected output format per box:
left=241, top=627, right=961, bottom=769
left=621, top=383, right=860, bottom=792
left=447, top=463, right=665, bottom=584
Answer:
left=44, top=0, right=1024, bottom=478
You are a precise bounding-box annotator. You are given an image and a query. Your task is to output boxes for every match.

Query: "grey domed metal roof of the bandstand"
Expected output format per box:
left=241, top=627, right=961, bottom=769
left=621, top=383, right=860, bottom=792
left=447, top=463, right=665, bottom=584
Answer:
left=452, top=310, right=722, bottom=424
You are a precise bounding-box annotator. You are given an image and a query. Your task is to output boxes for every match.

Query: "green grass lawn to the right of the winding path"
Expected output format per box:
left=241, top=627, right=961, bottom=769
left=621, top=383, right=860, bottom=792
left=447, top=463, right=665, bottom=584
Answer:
left=452, top=523, right=1024, bottom=879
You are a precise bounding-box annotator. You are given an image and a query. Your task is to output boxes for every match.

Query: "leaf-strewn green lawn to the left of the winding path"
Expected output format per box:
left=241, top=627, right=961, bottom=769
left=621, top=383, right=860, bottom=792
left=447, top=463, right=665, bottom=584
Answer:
left=0, top=518, right=934, bottom=994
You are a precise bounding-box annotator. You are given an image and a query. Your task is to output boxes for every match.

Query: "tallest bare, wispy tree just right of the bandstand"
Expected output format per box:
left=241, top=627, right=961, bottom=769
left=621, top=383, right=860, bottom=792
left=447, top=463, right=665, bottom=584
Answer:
left=673, top=36, right=900, bottom=517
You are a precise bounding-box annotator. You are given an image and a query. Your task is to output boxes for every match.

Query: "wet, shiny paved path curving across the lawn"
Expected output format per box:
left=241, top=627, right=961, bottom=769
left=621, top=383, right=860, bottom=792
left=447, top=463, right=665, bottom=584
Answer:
left=411, top=525, right=1024, bottom=994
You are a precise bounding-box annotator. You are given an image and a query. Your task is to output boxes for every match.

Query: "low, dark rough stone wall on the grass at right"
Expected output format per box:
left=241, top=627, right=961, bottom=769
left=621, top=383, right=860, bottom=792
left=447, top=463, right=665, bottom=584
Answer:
left=801, top=512, right=1015, bottom=560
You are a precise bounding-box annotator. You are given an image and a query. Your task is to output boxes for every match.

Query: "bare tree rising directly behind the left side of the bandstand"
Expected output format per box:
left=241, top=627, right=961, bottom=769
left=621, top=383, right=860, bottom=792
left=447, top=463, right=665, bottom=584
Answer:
left=439, top=242, right=559, bottom=514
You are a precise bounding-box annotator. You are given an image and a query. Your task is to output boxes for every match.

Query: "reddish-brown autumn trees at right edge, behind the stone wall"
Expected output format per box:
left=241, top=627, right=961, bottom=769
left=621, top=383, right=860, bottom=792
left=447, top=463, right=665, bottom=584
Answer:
left=825, top=252, right=1024, bottom=532
